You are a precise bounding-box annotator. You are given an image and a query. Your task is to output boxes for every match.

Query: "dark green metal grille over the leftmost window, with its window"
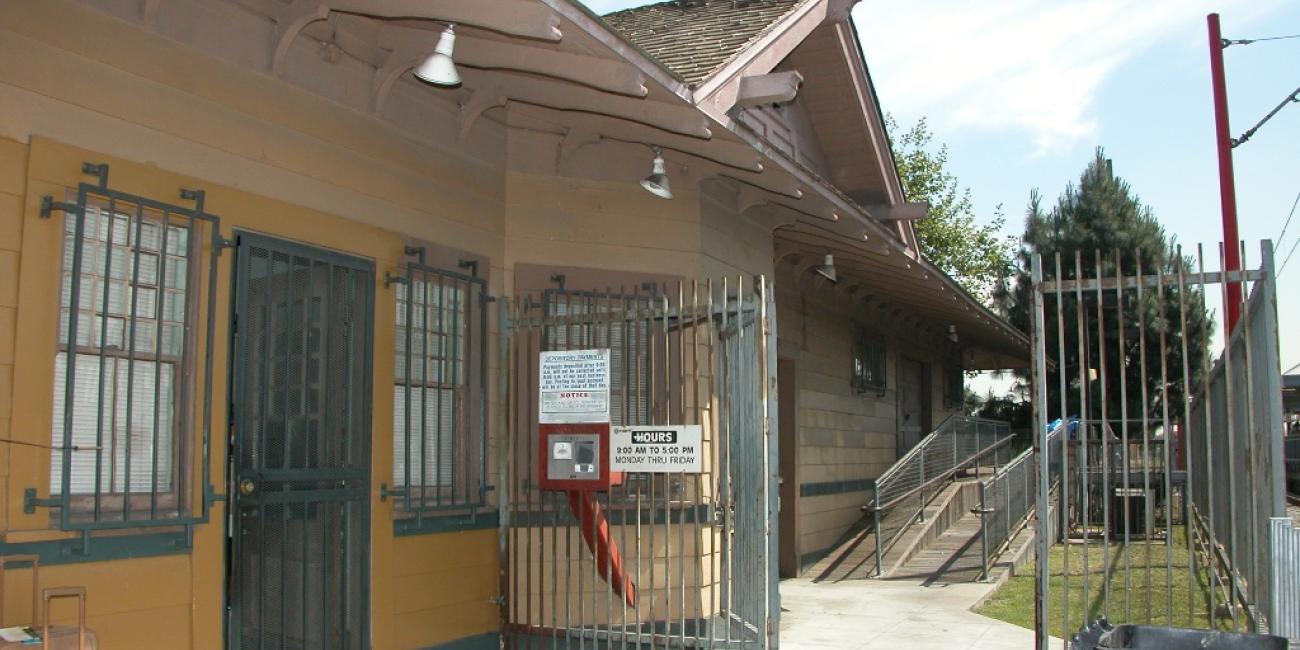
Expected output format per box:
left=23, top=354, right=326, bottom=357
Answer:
left=25, top=164, right=224, bottom=530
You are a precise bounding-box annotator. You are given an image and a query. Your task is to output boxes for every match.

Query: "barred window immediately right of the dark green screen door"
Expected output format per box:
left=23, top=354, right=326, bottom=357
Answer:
left=390, top=254, right=489, bottom=517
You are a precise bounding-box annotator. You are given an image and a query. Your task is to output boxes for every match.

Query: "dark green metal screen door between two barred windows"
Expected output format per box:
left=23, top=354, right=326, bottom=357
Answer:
left=228, top=233, right=374, bottom=650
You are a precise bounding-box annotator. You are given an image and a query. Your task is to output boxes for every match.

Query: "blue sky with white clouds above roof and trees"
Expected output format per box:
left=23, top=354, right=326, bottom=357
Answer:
left=586, top=0, right=1300, bottom=372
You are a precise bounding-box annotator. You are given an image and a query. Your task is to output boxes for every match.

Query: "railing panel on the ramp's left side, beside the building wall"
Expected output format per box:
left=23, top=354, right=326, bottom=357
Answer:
left=867, top=416, right=1014, bottom=576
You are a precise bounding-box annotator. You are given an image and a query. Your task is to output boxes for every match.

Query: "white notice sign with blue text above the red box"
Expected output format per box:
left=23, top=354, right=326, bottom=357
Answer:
left=537, top=350, right=610, bottom=424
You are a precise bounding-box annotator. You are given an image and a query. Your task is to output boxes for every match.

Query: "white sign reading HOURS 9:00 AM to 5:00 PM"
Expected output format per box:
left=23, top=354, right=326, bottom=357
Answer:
left=610, top=424, right=703, bottom=475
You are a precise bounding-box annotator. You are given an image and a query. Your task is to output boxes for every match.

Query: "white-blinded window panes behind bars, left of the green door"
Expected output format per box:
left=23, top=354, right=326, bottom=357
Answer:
left=49, top=205, right=190, bottom=499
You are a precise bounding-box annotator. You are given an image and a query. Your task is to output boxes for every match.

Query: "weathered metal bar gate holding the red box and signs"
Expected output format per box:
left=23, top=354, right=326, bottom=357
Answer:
left=501, top=278, right=780, bottom=649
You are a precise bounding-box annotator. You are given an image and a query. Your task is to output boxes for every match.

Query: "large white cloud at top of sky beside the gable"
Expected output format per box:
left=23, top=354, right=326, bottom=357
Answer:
left=854, top=0, right=1282, bottom=155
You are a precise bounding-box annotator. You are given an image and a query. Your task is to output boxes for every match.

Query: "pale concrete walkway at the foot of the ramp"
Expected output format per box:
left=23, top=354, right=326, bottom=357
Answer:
left=781, top=579, right=1034, bottom=650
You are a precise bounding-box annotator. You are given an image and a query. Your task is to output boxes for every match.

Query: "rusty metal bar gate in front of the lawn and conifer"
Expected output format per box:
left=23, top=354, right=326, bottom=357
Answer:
left=1031, top=242, right=1284, bottom=647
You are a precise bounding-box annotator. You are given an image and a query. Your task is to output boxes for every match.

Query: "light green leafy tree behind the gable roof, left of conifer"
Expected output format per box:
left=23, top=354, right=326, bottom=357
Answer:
left=885, top=116, right=1015, bottom=306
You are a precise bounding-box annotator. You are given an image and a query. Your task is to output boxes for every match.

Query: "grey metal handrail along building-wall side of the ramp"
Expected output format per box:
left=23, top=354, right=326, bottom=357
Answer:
left=862, top=416, right=1013, bottom=576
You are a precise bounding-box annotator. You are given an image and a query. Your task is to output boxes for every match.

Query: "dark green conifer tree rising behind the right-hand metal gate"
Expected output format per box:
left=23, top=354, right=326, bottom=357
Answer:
left=1000, top=147, right=1213, bottom=421
